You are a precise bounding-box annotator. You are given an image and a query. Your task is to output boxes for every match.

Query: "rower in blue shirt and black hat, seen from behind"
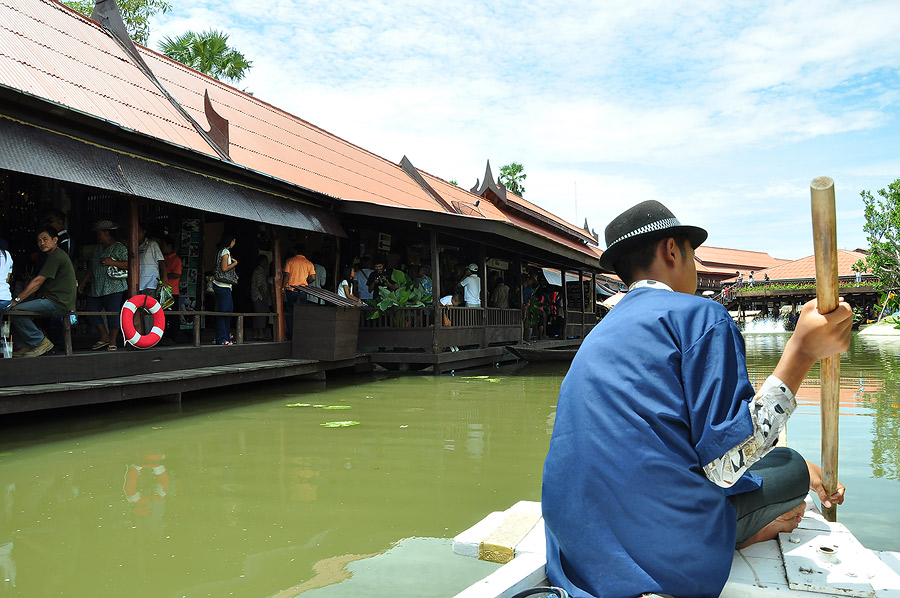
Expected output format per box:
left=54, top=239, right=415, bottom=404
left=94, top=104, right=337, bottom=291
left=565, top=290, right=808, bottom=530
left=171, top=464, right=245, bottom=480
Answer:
left=541, top=201, right=853, bottom=598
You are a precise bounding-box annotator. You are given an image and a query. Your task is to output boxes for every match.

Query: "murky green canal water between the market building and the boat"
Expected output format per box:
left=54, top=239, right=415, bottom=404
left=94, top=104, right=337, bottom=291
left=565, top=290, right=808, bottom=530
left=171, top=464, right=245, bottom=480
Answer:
left=0, top=334, right=900, bottom=598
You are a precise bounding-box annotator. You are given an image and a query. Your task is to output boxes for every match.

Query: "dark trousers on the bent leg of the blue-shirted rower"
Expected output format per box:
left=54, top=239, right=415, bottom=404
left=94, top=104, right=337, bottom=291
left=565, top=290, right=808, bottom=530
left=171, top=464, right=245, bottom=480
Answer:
left=728, top=447, right=809, bottom=546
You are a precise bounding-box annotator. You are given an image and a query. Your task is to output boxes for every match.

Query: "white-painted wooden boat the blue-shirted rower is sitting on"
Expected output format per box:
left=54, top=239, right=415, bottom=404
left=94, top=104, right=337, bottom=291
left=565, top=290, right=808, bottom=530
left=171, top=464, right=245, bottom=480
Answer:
left=453, top=495, right=900, bottom=598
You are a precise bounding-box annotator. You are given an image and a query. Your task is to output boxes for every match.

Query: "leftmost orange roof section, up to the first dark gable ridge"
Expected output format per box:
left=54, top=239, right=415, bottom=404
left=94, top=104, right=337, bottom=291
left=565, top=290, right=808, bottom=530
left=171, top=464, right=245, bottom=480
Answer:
left=0, top=0, right=214, bottom=154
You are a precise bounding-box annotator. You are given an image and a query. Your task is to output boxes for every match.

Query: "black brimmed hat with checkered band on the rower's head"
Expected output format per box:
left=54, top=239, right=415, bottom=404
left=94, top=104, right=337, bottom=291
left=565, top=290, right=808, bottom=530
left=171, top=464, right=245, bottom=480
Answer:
left=600, top=200, right=707, bottom=272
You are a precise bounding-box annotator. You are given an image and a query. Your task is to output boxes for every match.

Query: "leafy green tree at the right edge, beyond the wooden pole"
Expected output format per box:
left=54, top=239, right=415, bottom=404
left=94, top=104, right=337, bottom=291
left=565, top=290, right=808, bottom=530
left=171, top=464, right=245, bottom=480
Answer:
left=854, top=179, right=900, bottom=289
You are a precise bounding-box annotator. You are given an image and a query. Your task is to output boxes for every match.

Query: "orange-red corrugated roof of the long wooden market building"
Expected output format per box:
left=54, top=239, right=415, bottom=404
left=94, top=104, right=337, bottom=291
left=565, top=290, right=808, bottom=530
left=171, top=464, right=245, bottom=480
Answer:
left=0, top=0, right=599, bottom=268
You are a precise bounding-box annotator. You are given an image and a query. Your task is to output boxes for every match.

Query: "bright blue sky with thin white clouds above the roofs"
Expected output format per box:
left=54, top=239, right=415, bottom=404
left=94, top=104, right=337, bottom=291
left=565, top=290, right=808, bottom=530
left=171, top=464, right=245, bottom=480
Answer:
left=149, top=0, right=900, bottom=259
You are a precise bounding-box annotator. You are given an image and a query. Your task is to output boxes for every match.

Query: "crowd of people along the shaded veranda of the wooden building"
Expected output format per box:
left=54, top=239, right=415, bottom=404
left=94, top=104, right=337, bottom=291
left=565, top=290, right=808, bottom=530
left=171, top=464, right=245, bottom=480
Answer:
left=0, top=209, right=596, bottom=357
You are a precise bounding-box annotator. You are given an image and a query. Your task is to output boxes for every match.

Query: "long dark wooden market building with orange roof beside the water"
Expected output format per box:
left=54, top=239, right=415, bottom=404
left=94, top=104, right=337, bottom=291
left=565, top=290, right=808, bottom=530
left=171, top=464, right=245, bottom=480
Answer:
left=0, top=0, right=614, bottom=413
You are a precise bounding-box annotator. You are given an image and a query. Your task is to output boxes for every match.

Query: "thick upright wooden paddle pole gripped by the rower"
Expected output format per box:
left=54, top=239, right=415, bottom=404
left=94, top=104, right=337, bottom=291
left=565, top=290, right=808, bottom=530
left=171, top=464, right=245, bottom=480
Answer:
left=810, top=177, right=841, bottom=521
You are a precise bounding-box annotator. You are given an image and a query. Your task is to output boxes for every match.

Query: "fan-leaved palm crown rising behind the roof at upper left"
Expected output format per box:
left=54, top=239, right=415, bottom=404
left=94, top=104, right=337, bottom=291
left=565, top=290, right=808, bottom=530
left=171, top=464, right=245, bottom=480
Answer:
left=159, top=29, right=253, bottom=83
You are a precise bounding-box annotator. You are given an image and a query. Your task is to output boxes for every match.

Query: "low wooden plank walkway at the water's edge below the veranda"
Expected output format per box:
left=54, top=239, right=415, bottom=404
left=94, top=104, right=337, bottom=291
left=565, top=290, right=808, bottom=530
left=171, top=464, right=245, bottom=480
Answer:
left=0, top=359, right=355, bottom=415
